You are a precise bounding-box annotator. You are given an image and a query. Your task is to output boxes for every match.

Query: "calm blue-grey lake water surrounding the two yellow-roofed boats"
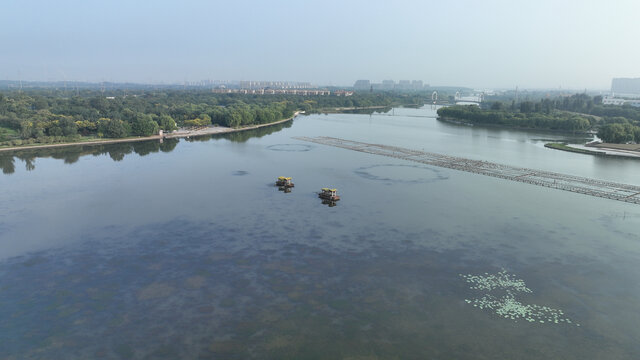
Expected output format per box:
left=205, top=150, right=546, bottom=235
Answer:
left=0, top=109, right=640, bottom=359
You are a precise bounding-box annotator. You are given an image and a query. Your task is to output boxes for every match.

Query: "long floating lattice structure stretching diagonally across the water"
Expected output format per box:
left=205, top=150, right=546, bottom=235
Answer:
left=294, top=136, right=640, bottom=205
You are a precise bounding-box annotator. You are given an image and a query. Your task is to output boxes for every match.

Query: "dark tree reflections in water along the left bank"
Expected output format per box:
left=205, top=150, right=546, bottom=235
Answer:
left=0, top=121, right=293, bottom=175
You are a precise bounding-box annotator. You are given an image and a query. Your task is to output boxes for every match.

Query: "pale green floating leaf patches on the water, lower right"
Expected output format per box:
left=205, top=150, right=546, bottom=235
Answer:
left=460, top=270, right=580, bottom=326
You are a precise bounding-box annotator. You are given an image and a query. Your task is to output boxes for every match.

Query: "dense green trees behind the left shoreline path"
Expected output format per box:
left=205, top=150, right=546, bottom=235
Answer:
left=0, top=89, right=427, bottom=145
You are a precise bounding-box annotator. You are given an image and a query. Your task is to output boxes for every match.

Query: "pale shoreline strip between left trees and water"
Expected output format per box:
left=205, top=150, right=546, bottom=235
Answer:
left=0, top=111, right=303, bottom=152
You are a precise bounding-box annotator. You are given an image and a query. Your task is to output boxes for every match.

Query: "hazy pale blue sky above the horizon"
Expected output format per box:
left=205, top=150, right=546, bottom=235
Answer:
left=0, top=0, right=640, bottom=89
